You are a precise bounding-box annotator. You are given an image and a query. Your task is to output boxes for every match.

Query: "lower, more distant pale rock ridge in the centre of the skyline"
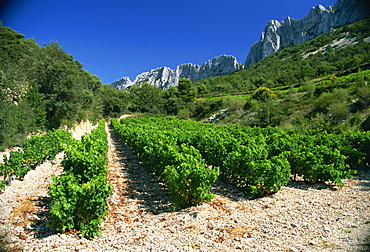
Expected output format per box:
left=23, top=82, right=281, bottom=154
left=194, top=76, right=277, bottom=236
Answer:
left=112, top=55, right=243, bottom=90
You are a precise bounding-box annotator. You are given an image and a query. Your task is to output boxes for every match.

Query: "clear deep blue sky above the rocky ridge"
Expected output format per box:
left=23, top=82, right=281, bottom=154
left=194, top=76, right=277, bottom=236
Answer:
left=0, top=0, right=336, bottom=83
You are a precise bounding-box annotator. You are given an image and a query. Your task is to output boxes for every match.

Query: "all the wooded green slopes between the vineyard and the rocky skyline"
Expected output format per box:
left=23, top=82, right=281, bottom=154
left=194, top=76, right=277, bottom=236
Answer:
left=0, top=17, right=370, bottom=153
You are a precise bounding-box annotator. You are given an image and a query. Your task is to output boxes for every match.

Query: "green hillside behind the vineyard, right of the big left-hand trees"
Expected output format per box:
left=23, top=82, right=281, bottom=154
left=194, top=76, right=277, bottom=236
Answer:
left=103, top=17, right=370, bottom=133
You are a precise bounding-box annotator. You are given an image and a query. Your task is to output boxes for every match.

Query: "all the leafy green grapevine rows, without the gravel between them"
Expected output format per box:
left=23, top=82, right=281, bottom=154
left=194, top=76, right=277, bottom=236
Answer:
left=0, top=117, right=370, bottom=238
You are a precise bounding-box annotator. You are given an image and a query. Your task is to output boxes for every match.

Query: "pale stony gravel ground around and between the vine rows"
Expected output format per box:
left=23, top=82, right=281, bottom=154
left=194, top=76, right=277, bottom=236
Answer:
left=0, top=122, right=370, bottom=251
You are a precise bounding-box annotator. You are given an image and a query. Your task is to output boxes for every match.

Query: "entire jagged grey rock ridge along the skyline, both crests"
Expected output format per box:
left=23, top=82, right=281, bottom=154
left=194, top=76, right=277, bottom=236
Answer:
left=111, top=0, right=370, bottom=90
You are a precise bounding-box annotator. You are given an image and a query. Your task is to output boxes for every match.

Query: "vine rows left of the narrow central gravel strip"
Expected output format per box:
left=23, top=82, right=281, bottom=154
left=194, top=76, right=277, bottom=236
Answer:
left=0, top=120, right=112, bottom=238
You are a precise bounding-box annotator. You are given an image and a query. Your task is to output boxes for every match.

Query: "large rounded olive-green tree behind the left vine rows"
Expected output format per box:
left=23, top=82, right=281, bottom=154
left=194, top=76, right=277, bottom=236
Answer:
left=22, top=42, right=102, bottom=128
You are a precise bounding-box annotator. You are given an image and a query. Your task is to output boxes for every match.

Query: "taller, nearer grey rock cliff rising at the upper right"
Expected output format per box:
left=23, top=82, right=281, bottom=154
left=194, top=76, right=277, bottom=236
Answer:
left=244, top=0, right=370, bottom=67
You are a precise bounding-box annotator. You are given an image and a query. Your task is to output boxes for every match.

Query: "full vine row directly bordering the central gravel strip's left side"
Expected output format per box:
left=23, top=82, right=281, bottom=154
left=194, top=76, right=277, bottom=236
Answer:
left=49, top=120, right=112, bottom=238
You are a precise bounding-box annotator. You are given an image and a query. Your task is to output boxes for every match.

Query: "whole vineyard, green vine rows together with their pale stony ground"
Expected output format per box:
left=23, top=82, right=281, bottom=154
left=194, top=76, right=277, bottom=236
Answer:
left=0, top=117, right=370, bottom=251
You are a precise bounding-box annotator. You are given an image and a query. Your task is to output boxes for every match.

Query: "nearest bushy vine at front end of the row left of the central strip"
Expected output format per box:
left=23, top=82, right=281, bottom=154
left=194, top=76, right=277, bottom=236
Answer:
left=49, top=172, right=112, bottom=238
